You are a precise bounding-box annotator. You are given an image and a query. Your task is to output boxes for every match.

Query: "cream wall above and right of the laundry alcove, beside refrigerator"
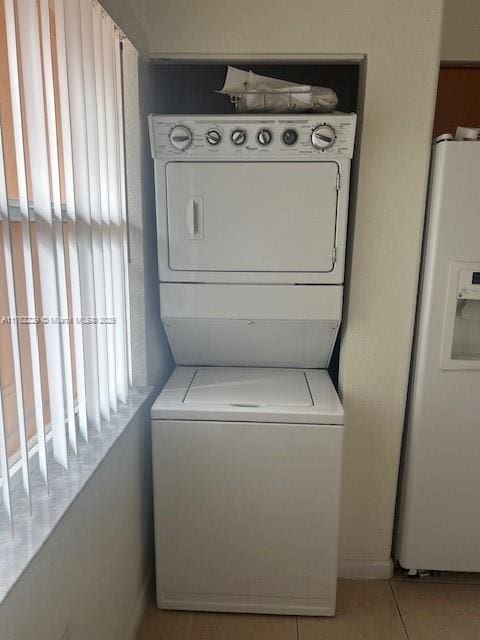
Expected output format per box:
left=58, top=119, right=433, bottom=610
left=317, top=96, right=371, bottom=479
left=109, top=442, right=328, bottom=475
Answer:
left=111, top=0, right=443, bottom=574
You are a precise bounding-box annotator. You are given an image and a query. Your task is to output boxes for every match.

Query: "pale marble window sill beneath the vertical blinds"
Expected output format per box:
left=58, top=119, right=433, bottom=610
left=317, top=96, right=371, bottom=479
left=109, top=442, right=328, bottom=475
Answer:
left=0, top=387, right=152, bottom=604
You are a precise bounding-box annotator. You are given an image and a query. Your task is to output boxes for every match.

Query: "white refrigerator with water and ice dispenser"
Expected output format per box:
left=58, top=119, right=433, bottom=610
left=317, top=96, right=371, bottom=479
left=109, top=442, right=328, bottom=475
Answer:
left=396, top=136, right=480, bottom=573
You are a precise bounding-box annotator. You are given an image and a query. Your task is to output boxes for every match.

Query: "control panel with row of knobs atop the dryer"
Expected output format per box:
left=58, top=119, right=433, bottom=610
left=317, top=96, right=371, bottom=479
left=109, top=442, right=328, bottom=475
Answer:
left=149, top=113, right=356, bottom=160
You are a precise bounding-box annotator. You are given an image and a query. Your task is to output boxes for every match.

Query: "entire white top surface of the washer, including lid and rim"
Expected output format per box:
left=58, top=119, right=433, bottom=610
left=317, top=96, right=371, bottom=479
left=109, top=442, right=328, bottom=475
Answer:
left=151, top=367, right=344, bottom=425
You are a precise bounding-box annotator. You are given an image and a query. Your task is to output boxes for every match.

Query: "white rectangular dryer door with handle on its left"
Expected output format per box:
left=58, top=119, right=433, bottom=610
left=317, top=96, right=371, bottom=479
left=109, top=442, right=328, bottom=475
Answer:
left=166, top=162, right=339, bottom=272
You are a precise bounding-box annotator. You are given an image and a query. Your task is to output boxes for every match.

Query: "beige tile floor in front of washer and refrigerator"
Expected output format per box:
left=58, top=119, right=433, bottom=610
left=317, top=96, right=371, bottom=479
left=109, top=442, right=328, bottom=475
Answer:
left=137, top=574, right=480, bottom=640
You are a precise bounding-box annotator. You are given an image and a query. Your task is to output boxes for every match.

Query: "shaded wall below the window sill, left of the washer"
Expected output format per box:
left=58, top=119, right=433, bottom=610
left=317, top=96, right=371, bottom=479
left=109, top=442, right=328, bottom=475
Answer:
left=0, top=406, right=153, bottom=640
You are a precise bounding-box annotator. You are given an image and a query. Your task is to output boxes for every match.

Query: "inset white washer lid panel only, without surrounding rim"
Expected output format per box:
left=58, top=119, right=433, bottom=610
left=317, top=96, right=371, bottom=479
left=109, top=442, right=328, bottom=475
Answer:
left=184, top=367, right=313, bottom=407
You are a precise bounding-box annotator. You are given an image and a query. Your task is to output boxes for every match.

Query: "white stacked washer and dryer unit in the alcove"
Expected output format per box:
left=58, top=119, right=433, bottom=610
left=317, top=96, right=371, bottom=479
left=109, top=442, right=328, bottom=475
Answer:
left=149, top=113, right=356, bottom=615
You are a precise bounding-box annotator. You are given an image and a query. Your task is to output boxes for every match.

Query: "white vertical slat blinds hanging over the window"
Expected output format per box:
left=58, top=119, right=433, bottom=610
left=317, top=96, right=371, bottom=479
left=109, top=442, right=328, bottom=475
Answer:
left=0, top=0, right=132, bottom=521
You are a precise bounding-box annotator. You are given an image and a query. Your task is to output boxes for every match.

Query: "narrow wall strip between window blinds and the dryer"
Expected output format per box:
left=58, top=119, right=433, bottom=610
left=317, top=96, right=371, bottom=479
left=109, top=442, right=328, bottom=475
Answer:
left=123, top=41, right=173, bottom=388
